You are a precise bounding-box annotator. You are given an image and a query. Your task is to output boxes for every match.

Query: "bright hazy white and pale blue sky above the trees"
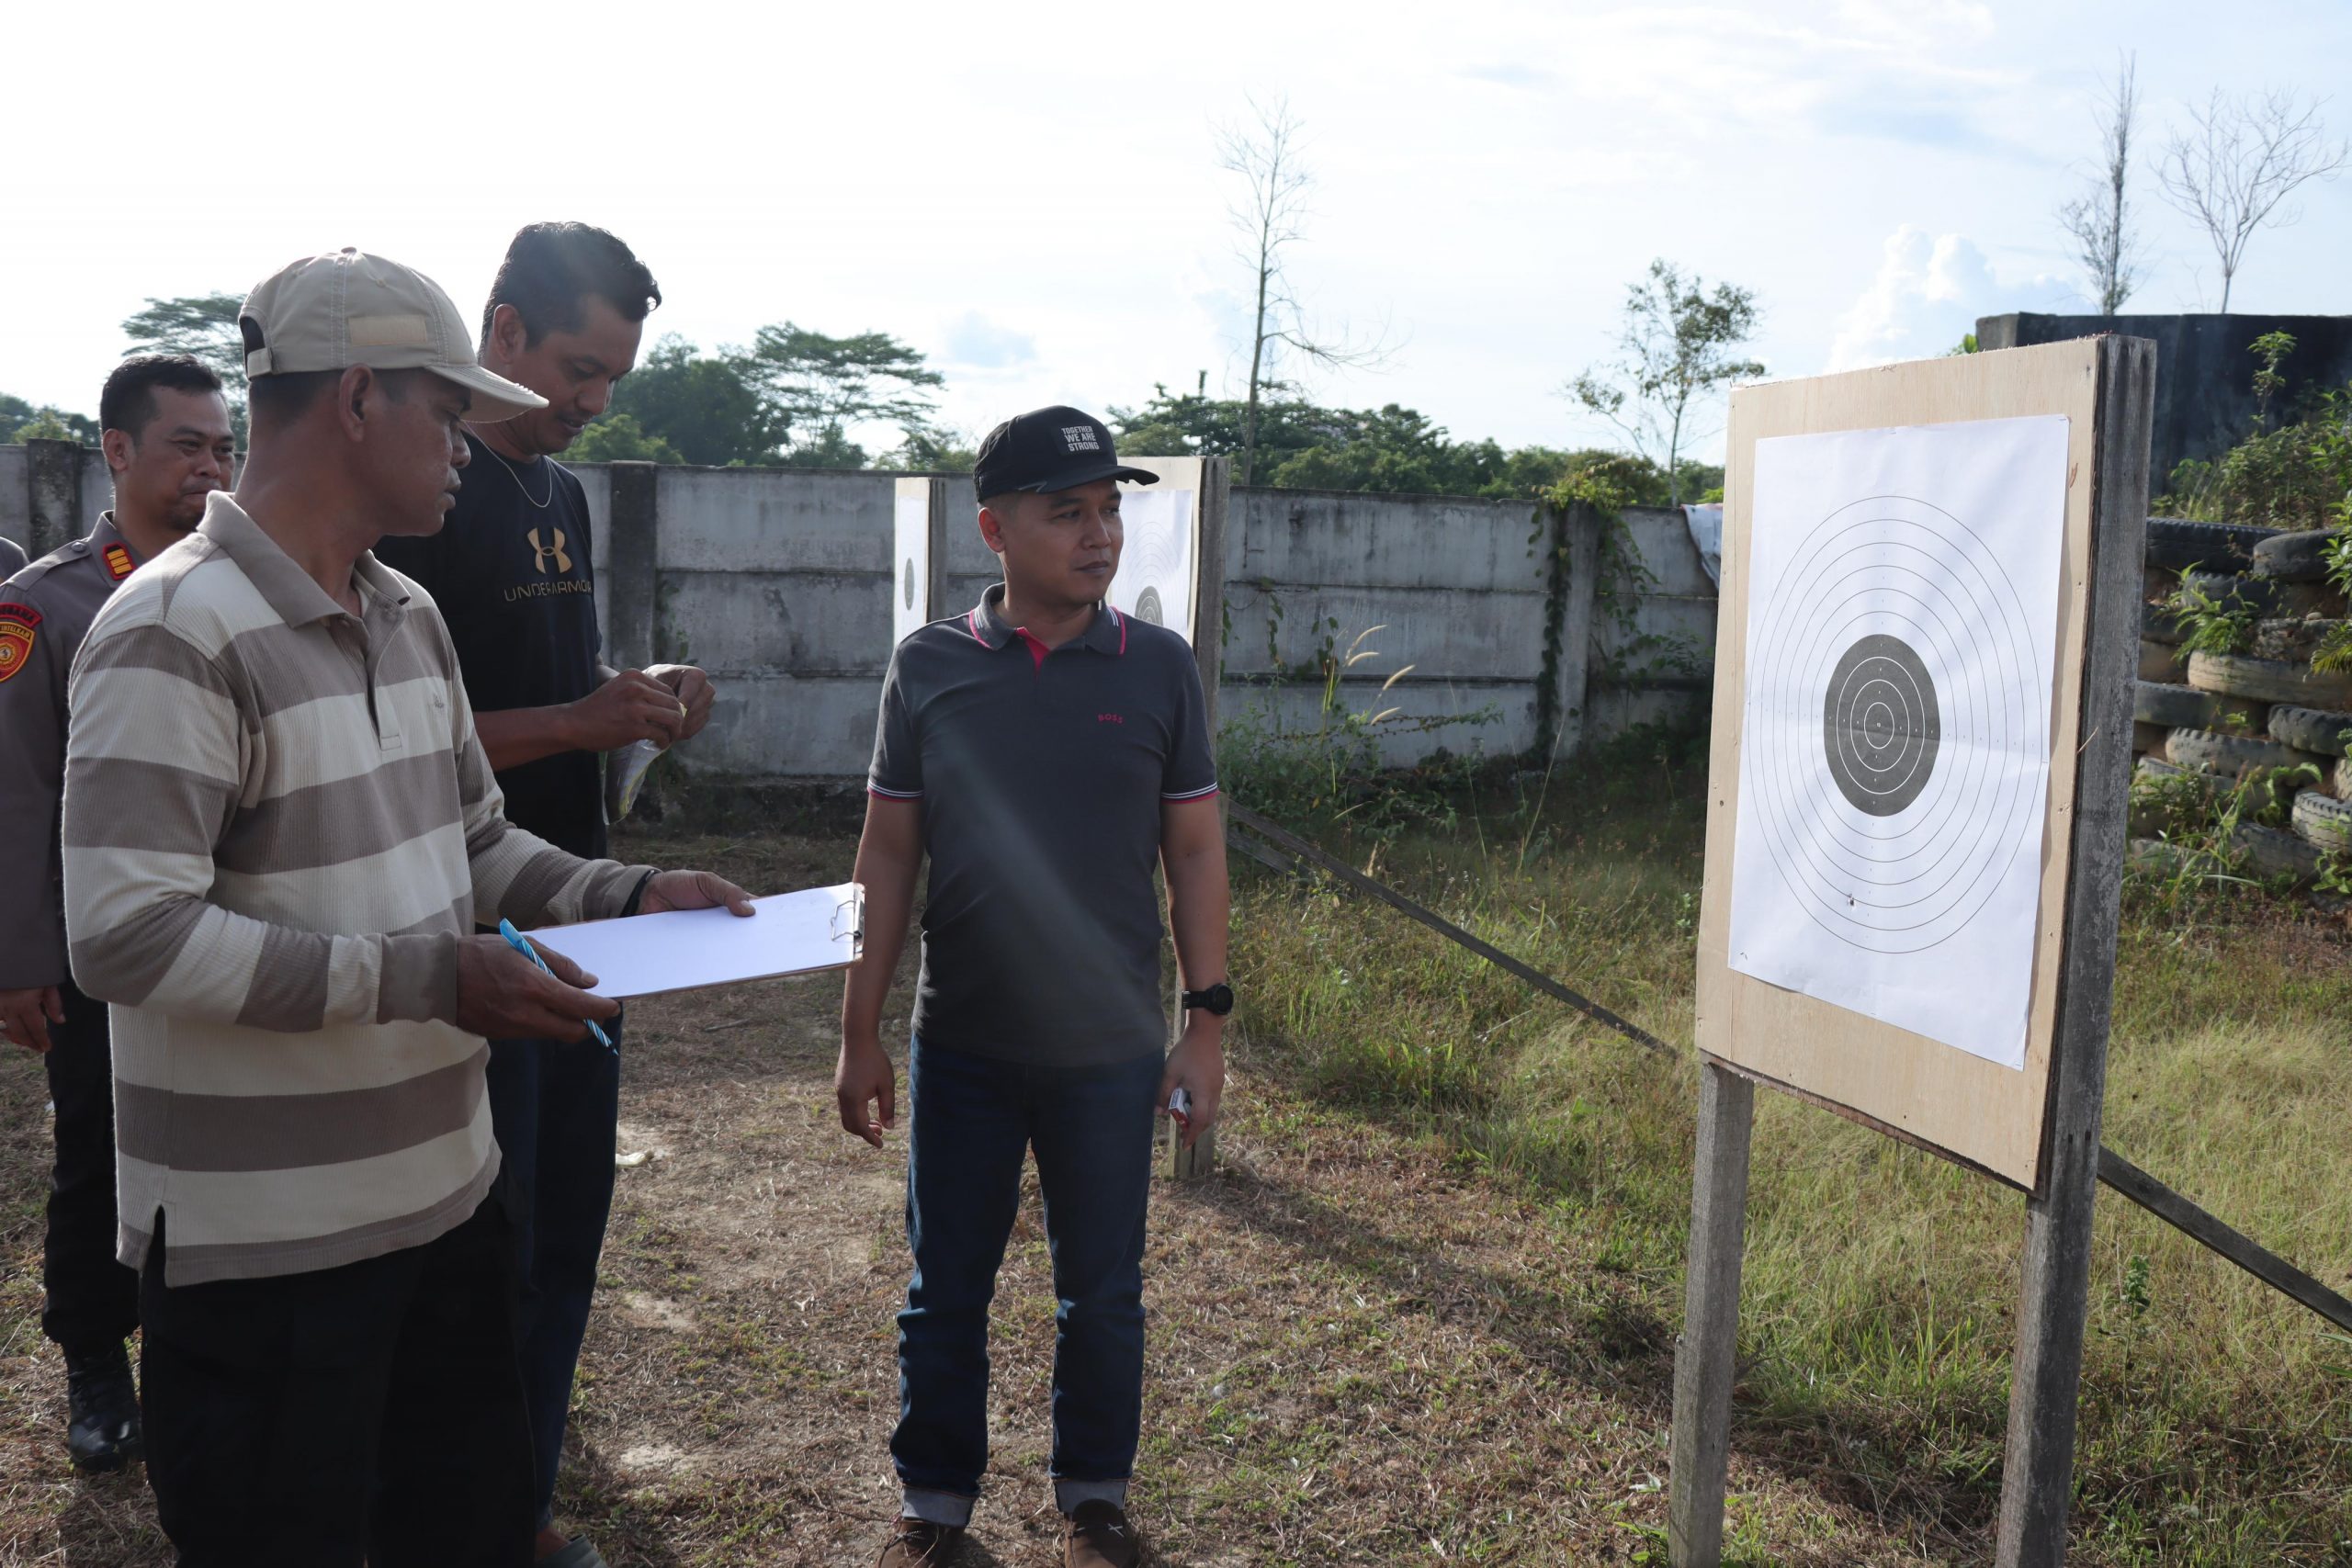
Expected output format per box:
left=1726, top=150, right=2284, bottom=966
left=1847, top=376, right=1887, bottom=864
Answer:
left=0, top=0, right=2352, bottom=460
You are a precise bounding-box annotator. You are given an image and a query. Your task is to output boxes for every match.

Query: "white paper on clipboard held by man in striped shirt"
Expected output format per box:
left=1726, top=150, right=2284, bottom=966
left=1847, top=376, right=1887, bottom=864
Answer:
left=525, top=882, right=865, bottom=1001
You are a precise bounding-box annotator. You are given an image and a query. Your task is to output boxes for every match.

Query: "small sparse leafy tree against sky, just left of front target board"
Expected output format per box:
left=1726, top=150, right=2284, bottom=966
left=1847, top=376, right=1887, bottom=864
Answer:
left=1566, top=261, right=1764, bottom=505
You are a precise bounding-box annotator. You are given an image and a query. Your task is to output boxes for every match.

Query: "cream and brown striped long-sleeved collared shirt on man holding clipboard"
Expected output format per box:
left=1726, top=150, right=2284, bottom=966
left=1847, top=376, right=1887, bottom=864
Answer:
left=63, top=493, right=644, bottom=1286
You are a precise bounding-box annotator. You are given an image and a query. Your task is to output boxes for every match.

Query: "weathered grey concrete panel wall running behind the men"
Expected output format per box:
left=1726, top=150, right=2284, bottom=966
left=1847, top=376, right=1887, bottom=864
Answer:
left=0, top=442, right=1714, bottom=776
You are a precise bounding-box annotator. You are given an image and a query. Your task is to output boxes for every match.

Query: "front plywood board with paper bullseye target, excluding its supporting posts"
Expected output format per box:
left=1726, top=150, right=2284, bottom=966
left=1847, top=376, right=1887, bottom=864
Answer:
left=1696, top=339, right=2144, bottom=1190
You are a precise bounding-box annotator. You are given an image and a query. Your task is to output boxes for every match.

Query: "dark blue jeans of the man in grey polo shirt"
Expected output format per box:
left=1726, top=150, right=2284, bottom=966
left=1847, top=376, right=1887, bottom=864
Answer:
left=891, top=1039, right=1162, bottom=1497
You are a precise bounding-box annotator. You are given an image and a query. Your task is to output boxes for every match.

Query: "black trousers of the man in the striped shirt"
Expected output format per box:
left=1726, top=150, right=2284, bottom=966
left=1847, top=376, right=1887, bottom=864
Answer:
left=139, top=1201, right=534, bottom=1568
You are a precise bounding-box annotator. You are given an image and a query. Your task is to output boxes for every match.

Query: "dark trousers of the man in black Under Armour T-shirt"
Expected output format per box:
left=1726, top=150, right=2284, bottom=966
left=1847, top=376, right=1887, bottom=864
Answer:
left=489, top=1018, right=621, bottom=1528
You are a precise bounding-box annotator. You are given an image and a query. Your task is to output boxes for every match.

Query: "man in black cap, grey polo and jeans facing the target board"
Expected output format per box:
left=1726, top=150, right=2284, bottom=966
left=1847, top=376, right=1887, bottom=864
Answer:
left=835, top=407, right=1232, bottom=1568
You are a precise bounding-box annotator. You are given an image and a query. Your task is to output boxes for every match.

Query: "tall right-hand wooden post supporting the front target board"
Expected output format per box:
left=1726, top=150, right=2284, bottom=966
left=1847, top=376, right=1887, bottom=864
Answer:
left=1995, top=339, right=2157, bottom=1568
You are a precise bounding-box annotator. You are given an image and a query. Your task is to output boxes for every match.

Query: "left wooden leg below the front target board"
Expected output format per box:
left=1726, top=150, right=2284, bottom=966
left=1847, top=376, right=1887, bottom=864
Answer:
left=1665, top=1060, right=1757, bottom=1568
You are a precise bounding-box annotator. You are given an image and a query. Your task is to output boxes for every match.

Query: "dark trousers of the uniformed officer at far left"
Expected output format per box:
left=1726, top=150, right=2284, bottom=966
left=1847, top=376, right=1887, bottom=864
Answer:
left=40, top=980, right=139, bottom=1352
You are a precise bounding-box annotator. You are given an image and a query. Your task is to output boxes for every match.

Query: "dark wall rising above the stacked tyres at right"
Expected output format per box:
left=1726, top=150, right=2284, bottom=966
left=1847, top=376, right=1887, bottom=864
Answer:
left=1975, top=312, right=2352, bottom=496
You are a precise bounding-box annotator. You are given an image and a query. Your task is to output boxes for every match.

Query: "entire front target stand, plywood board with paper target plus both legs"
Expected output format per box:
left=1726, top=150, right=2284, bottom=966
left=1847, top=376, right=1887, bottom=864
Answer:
left=1668, top=336, right=2157, bottom=1568
